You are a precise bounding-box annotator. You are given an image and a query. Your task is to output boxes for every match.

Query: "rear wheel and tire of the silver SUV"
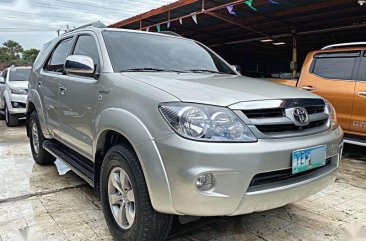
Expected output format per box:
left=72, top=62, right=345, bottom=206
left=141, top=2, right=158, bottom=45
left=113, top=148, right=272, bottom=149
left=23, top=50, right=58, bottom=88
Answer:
left=28, top=111, right=56, bottom=165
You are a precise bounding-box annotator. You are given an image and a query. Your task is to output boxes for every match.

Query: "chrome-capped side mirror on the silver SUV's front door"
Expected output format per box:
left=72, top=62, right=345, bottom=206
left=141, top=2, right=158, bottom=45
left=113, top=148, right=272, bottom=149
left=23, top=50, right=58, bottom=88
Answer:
left=64, top=55, right=95, bottom=77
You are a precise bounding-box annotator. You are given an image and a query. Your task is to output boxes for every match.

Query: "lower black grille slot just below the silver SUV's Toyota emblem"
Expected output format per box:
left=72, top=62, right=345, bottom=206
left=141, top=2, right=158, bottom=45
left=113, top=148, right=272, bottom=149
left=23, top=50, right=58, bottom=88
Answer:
left=256, top=119, right=327, bottom=134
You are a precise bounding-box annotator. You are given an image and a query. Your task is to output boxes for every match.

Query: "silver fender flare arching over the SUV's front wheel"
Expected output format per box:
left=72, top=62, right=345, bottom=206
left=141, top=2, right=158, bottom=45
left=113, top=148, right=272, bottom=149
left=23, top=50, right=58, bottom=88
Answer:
left=93, top=108, right=176, bottom=213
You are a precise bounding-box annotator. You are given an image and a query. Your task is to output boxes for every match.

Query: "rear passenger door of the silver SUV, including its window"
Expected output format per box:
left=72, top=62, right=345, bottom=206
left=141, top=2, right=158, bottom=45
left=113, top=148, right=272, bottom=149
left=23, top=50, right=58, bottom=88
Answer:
left=36, top=37, right=73, bottom=139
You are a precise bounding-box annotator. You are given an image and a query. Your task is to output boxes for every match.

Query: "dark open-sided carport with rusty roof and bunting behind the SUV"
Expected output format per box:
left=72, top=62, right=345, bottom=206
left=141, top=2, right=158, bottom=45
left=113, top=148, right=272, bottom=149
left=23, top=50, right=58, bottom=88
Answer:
left=110, top=0, right=366, bottom=77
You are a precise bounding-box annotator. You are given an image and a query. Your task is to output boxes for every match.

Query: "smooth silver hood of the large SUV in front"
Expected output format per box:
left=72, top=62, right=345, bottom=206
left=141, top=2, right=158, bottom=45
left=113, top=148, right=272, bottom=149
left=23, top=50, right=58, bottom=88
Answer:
left=122, top=72, right=320, bottom=106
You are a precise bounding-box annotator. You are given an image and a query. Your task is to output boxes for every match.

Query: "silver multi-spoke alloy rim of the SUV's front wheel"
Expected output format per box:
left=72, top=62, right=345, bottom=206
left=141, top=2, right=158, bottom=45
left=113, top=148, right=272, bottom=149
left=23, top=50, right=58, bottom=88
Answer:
left=108, top=167, right=136, bottom=229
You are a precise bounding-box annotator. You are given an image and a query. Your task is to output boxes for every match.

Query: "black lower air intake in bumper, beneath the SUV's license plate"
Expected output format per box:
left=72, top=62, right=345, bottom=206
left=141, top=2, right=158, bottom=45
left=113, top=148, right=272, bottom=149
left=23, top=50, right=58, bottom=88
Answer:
left=249, top=158, right=332, bottom=187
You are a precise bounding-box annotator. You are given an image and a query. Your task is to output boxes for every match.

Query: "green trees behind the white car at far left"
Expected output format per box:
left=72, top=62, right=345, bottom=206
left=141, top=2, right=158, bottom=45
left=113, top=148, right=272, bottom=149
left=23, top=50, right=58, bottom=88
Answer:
left=0, top=40, right=39, bottom=66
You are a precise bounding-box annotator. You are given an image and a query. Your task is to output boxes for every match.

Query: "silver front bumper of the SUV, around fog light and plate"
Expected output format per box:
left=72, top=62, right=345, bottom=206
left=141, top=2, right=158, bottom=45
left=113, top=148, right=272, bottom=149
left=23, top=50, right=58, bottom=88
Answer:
left=144, top=128, right=343, bottom=216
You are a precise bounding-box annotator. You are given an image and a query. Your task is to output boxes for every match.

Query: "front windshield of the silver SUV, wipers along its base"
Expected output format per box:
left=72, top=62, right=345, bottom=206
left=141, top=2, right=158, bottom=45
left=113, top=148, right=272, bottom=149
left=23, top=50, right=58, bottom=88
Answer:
left=103, top=31, right=235, bottom=74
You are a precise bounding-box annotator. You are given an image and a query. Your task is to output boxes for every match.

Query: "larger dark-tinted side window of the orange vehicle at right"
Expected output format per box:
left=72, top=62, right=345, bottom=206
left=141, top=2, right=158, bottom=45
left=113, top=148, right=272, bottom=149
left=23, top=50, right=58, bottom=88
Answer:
left=311, top=51, right=361, bottom=80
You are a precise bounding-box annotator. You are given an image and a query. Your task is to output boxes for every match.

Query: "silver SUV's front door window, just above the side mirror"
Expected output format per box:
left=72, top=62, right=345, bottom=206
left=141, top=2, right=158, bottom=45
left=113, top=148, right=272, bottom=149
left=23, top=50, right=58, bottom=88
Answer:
left=72, top=35, right=99, bottom=72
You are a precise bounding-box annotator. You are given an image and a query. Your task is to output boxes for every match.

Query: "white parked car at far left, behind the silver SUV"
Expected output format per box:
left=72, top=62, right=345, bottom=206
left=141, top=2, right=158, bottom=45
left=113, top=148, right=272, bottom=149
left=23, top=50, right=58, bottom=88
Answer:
left=0, top=66, right=31, bottom=126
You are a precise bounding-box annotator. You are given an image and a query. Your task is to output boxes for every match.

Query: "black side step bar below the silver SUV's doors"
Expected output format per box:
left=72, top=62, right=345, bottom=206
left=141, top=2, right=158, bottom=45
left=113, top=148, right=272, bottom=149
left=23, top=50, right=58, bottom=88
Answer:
left=43, top=140, right=94, bottom=187
